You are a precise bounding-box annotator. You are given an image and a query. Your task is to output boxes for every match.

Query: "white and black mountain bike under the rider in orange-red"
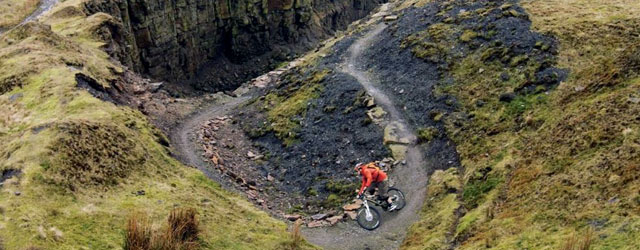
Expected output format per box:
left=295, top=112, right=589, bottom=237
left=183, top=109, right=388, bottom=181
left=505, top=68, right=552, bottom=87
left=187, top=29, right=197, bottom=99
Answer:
left=356, top=188, right=406, bottom=231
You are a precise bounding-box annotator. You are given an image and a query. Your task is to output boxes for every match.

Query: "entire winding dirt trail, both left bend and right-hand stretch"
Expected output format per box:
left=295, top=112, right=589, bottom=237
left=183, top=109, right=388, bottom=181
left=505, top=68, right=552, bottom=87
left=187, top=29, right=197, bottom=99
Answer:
left=170, top=20, right=428, bottom=249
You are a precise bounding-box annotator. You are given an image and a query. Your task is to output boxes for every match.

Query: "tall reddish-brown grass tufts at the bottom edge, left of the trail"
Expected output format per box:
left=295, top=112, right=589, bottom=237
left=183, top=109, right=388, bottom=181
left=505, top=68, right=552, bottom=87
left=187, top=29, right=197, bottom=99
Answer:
left=124, top=208, right=200, bottom=250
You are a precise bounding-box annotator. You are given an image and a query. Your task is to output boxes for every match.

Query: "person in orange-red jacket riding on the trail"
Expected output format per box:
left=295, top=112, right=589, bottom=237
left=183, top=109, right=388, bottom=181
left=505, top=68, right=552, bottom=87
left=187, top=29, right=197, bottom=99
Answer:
left=354, top=162, right=393, bottom=208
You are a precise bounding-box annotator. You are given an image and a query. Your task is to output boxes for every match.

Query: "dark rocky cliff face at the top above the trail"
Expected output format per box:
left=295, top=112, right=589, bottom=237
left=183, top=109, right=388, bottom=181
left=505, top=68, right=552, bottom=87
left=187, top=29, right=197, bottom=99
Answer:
left=85, top=0, right=385, bottom=90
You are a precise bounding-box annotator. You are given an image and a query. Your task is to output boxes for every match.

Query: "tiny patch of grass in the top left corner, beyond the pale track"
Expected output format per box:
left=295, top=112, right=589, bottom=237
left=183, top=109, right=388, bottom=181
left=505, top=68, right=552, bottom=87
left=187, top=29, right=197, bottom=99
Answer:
left=0, top=0, right=40, bottom=28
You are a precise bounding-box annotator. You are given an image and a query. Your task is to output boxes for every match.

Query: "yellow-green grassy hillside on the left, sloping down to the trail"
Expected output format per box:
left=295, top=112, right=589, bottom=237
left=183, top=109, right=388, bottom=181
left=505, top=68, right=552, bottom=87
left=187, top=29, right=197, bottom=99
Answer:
left=0, top=1, right=308, bottom=249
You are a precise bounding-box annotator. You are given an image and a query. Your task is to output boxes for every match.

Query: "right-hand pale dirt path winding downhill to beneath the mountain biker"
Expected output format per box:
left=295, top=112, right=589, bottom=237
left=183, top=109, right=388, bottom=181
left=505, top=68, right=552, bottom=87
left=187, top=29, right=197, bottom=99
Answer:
left=303, top=23, right=428, bottom=249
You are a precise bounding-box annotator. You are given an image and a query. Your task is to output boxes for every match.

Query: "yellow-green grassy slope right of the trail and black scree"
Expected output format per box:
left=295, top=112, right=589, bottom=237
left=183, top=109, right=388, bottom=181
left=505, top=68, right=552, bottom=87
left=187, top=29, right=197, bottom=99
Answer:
left=403, top=0, right=640, bottom=249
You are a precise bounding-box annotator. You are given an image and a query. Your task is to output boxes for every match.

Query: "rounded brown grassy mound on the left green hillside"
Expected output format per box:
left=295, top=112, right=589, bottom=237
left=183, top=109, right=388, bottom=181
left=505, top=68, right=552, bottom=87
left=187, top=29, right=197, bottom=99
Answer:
left=47, top=121, right=146, bottom=191
